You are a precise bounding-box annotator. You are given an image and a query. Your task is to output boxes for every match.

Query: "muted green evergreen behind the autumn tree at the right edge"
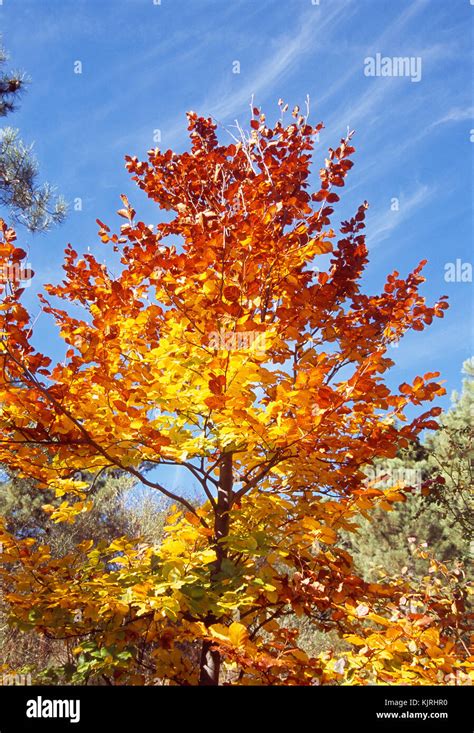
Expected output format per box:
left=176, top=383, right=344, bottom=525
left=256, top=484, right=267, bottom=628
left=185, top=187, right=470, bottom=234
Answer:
left=347, top=359, right=474, bottom=580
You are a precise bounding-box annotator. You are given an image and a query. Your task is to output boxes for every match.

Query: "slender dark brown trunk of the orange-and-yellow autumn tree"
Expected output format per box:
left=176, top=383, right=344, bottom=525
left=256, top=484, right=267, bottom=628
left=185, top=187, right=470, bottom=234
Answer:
left=199, top=453, right=233, bottom=686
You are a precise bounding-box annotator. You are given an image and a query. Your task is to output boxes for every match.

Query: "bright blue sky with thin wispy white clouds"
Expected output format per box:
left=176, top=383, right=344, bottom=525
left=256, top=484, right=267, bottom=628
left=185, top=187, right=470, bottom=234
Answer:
left=0, top=0, right=474, bottom=498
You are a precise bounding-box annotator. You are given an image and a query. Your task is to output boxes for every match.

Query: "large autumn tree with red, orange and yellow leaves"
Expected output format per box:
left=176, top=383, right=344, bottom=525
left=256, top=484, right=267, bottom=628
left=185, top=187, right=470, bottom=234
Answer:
left=0, top=108, right=467, bottom=685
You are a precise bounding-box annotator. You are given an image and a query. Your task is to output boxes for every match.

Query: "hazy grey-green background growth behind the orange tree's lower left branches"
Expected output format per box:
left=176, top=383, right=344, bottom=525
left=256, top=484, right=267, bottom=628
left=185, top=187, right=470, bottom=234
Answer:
left=0, top=466, right=167, bottom=684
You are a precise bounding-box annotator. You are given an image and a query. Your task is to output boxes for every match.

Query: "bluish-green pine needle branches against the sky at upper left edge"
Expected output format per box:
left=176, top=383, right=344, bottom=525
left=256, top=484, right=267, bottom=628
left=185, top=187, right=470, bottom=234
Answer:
left=0, top=43, right=67, bottom=232
